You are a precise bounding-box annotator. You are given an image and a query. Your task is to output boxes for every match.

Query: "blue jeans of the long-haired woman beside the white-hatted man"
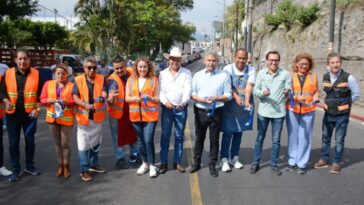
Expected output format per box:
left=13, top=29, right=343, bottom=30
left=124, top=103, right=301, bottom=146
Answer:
left=132, top=122, right=157, bottom=165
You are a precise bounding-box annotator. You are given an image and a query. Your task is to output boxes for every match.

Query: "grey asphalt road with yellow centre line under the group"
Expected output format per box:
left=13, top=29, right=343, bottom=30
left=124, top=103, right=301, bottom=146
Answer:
left=0, top=58, right=364, bottom=205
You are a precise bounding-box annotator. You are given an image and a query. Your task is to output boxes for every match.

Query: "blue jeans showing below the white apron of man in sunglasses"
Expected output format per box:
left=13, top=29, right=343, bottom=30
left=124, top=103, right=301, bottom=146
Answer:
left=78, top=144, right=100, bottom=173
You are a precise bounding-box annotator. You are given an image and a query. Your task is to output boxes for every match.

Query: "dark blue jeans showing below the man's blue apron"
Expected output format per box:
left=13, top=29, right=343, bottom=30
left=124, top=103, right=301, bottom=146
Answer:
left=220, top=132, right=243, bottom=159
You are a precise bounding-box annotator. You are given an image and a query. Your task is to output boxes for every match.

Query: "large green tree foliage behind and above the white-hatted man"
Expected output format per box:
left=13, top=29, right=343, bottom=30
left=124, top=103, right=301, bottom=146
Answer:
left=71, top=0, right=195, bottom=58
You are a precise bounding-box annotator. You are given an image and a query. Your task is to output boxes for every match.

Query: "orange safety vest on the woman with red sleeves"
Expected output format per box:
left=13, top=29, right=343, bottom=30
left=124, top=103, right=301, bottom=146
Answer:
left=46, top=80, right=74, bottom=126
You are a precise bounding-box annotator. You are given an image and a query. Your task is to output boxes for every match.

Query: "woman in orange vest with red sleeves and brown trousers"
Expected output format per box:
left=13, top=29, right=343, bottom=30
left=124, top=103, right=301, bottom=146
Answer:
left=40, top=64, right=74, bottom=179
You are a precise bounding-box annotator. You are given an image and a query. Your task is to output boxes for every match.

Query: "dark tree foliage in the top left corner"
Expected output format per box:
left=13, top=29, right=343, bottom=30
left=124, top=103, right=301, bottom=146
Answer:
left=0, top=0, right=38, bottom=21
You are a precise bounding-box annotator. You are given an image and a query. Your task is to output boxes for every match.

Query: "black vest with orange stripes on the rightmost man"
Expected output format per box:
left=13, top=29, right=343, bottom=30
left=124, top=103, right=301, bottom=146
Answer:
left=323, top=70, right=352, bottom=115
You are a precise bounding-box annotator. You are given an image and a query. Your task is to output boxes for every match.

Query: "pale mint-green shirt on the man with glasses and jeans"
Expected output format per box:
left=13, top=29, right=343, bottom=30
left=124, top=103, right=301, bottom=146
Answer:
left=253, top=68, right=292, bottom=118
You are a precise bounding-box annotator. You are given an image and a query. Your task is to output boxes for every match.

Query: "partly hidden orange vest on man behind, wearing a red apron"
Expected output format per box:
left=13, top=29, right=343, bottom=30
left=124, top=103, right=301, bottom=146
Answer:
left=107, top=73, right=125, bottom=119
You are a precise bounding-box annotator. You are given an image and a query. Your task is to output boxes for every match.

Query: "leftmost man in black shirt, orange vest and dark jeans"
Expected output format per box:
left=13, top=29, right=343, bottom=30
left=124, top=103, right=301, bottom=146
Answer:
left=0, top=49, right=42, bottom=182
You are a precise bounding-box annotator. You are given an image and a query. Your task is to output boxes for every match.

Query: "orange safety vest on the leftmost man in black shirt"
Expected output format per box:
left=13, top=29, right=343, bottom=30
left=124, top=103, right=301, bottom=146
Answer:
left=5, top=68, right=39, bottom=114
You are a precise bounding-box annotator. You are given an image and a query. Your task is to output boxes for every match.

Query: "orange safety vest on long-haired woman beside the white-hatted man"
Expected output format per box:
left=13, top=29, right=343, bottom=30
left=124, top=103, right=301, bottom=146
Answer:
left=127, top=77, right=159, bottom=122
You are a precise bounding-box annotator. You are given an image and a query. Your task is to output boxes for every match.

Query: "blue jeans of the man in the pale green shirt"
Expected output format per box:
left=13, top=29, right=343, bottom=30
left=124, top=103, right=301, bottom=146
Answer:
left=253, top=114, right=284, bottom=167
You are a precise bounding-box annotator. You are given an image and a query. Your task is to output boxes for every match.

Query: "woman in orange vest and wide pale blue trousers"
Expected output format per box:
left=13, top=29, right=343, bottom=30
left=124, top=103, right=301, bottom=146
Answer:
left=287, top=53, right=319, bottom=175
